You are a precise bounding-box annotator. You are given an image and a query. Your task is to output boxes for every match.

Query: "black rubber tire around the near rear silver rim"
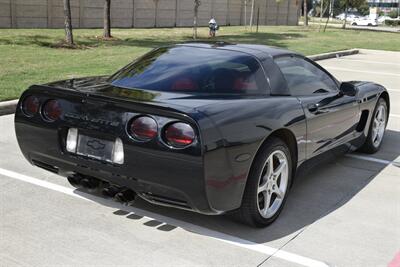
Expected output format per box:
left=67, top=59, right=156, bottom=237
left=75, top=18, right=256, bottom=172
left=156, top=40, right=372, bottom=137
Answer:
left=234, top=137, right=292, bottom=227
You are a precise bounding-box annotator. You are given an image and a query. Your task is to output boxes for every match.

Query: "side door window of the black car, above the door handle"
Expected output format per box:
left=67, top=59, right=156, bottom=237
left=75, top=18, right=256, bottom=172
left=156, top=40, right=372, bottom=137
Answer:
left=275, top=57, right=338, bottom=96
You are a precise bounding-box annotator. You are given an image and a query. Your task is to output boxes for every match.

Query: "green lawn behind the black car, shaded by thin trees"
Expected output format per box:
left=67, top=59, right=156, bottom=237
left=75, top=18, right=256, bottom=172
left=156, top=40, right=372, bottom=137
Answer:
left=0, top=26, right=400, bottom=101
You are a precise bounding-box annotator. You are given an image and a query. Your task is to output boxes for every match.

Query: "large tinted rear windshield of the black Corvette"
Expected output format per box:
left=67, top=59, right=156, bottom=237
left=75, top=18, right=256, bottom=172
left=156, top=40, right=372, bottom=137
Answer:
left=109, top=46, right=266, bottom=94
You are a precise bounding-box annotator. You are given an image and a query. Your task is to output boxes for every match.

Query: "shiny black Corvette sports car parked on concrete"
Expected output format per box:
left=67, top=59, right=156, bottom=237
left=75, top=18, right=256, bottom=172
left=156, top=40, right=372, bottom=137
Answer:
left=15, top=43, right=390, bottom=226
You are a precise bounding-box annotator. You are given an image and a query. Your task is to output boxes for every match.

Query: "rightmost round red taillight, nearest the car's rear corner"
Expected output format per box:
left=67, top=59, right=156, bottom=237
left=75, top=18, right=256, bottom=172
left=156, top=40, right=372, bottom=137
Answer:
left=164, top=122, right=195, bottom=148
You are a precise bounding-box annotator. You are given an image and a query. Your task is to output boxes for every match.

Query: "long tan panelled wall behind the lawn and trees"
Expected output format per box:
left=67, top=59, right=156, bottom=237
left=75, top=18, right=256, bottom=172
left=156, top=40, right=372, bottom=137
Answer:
left=0, top=0, right=299, bottom=28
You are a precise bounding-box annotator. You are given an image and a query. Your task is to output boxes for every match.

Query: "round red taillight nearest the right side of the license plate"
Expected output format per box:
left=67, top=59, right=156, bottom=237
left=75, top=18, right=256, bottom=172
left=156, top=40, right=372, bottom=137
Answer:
left=130, top=116, right=158, bottom=141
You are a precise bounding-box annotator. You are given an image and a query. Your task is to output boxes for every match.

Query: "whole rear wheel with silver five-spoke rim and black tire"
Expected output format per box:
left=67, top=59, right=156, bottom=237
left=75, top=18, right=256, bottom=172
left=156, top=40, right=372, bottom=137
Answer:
left=236, top=137, right=292, bottom=227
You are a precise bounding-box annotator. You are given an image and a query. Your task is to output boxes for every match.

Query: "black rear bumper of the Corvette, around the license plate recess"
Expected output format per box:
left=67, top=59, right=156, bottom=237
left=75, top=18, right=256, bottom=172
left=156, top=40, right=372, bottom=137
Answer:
left=15, top=120, right=224, bottom=214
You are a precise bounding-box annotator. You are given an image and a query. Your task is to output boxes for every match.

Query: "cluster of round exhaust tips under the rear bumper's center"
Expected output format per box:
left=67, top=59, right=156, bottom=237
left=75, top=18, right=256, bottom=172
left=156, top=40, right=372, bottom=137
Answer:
left=67, top=174, right=136, bottom=204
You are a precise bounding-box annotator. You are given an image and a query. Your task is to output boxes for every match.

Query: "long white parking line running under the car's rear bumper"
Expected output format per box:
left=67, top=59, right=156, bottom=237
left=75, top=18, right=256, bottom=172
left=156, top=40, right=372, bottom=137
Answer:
left=0, top=168, right=329, bottom=267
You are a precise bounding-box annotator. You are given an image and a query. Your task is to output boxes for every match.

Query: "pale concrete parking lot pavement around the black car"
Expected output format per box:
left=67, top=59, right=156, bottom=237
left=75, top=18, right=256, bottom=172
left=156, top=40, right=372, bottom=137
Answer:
left=0, top=50, right=400, bottom=267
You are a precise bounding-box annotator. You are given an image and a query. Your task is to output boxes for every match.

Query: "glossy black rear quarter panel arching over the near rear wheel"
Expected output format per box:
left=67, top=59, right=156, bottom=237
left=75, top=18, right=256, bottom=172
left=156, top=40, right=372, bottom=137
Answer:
left=199, top=96, right=306, bottom=211
